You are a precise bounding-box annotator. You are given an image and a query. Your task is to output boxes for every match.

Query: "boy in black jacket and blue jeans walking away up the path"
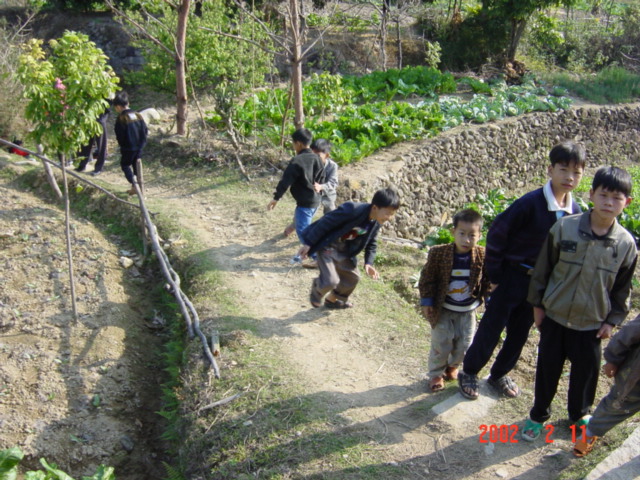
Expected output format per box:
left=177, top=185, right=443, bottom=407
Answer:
left=267, top=128, right=323, bottom=249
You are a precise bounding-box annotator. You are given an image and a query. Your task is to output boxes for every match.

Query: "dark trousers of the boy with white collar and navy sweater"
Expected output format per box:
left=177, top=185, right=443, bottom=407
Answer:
left=463, top=266, right=533, bottom=379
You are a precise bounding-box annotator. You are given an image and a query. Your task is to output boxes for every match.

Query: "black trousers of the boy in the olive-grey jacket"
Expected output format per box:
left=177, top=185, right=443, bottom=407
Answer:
left=529, top=317, right=602, bottom=422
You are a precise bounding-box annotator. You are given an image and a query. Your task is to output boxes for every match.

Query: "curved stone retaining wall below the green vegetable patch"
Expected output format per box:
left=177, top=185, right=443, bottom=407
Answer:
left=338, top=104, right=640, bottom=241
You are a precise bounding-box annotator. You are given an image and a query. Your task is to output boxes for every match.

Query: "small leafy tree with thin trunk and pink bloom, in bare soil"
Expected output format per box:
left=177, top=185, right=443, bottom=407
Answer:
left=18, top=31, right=118, bottom=319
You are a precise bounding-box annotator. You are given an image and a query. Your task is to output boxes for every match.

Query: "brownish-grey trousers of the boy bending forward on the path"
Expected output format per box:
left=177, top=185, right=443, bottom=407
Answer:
left=313, top=242, right=360, bottom=301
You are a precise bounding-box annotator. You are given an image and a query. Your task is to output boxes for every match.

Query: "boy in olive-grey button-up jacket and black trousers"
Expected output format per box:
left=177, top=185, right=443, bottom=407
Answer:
left=522, top=167, right=637, bottom=440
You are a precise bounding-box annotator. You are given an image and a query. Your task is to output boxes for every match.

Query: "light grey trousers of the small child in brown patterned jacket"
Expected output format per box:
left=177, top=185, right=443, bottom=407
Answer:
left=429, top=308, right=476, bottom=378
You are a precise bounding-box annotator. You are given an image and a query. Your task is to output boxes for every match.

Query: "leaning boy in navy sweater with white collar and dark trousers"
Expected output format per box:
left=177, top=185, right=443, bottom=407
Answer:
left=458, top=141, right=585, bottom=400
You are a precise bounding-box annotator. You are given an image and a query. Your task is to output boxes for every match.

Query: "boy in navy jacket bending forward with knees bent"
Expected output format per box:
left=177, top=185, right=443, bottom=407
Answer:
left=298, top=188, right=400, bottom=308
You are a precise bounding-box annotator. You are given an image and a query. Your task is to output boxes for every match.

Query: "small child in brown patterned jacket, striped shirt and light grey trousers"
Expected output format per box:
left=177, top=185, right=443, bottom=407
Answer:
left=418, top=209, right=489, bottom=392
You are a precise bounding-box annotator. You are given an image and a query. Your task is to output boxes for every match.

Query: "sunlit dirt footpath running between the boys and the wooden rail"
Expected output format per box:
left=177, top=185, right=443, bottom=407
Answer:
left=140, top=167, right=570, bottom=479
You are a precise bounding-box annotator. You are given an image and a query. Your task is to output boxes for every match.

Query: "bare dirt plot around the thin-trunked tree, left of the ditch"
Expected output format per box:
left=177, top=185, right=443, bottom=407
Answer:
left=0, top=166, right=168, bottom=480
